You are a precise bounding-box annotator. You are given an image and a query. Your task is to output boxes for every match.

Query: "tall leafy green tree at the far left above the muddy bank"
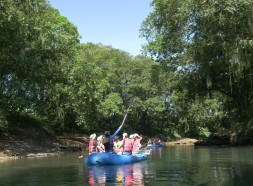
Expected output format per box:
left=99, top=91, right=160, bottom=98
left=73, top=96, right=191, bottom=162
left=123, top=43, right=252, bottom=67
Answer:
left=0, top=0, right=79, bottom=129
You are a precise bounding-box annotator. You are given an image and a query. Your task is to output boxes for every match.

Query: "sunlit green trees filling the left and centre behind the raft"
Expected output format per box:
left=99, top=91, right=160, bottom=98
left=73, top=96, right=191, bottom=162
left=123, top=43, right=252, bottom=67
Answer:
left=0, top=0, right=170, bottom=137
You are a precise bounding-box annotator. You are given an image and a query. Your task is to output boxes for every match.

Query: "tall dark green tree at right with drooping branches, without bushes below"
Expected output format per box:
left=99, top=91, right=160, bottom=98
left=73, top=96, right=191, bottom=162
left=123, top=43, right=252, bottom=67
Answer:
left=141, top=0, right=253, bottom=134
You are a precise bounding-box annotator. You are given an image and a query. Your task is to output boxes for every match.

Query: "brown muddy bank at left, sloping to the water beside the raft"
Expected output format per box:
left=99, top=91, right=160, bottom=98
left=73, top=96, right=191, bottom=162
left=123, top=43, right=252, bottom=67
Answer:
left=0, top=134, right=88, bottom=161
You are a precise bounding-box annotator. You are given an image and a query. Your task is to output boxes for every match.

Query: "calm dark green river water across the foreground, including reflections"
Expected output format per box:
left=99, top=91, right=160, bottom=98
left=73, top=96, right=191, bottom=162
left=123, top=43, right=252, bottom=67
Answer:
left=0, top=146, right=253, bottom=186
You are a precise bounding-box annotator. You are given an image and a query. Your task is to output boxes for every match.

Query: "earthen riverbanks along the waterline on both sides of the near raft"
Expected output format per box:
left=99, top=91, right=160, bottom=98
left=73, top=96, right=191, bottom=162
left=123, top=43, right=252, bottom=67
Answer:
left=0, top=117, right=253, bottom=162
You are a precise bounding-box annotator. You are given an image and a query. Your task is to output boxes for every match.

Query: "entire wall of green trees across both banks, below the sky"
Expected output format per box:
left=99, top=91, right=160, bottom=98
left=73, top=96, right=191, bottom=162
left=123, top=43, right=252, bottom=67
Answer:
left=0, top=0, right=253, bottom=136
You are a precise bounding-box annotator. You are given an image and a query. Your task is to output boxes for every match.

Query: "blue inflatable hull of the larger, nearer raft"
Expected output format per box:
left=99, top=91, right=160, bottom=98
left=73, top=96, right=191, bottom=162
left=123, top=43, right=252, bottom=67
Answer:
left=85, top=152, right=147, bottom=165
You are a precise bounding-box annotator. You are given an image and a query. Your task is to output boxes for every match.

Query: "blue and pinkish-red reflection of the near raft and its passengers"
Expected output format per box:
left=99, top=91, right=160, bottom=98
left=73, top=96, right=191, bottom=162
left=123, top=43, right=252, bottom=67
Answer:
left=87, top=162, right=145, bottom=186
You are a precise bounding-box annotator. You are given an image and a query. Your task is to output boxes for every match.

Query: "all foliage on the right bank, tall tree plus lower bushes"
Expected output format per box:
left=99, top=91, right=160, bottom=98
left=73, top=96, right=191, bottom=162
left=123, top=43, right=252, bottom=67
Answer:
left=141, top=0, right=253, bottom=135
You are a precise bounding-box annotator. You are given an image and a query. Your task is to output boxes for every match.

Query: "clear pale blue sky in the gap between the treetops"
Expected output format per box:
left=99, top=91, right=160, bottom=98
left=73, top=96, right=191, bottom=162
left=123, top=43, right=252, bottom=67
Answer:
left=49, top=0, right=152, bottom=56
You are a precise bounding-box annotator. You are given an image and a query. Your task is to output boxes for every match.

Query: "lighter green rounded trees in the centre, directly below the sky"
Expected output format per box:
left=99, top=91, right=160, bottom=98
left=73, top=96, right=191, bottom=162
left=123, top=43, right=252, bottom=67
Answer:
left=60, top=43, right=165, bottom=132
